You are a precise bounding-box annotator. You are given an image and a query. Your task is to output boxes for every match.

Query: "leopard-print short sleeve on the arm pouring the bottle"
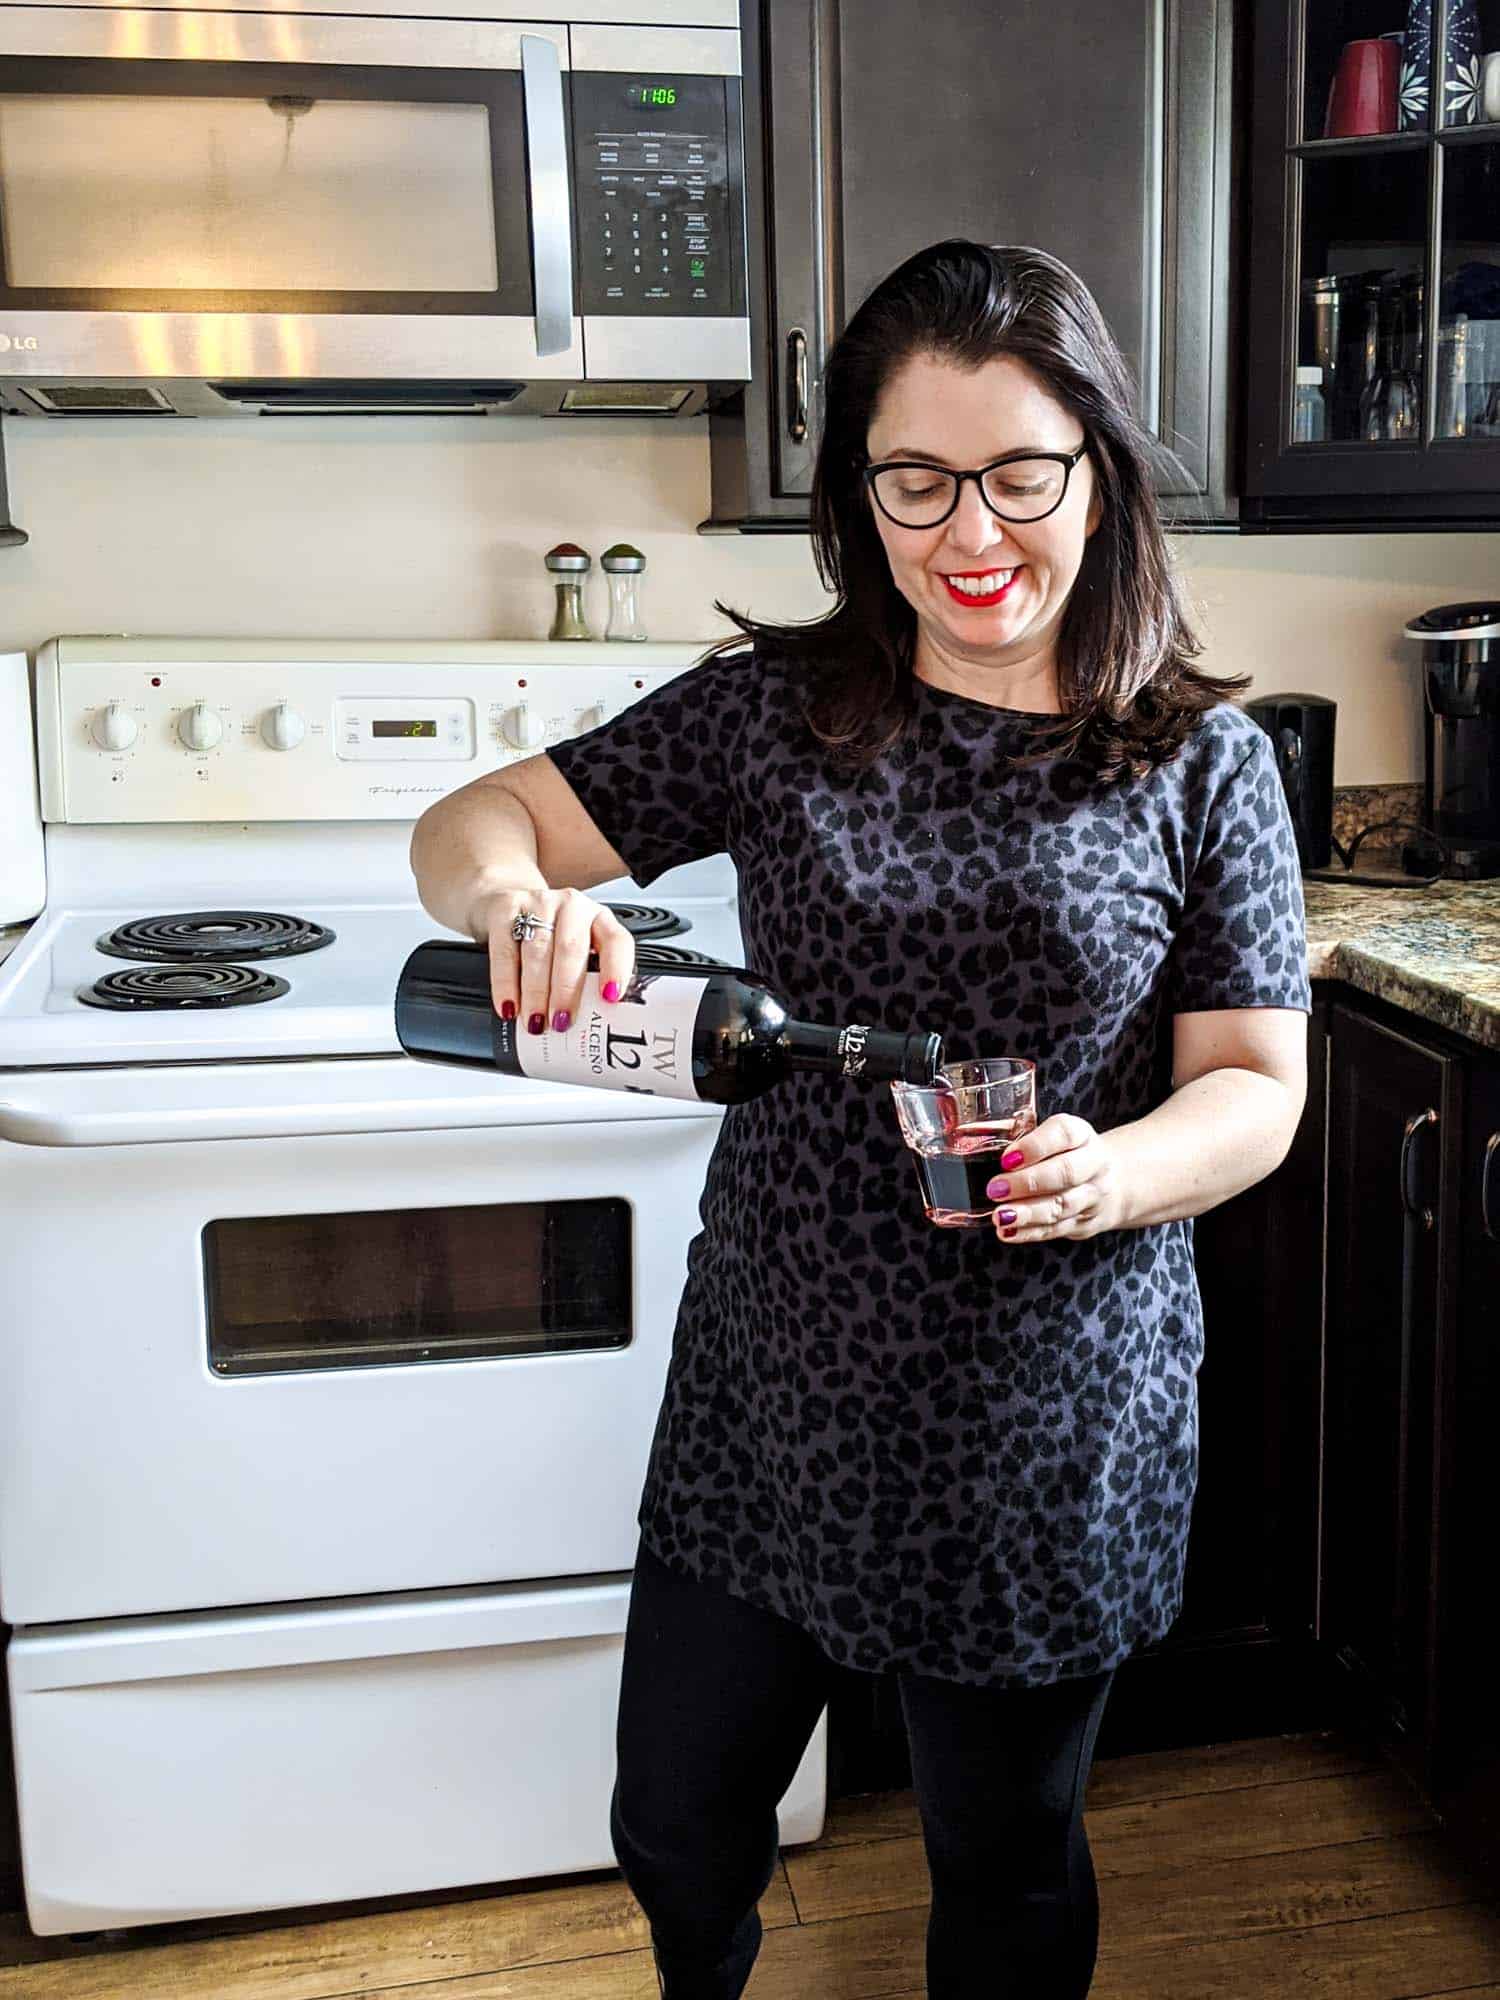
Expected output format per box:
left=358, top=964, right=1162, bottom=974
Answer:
left=548, top=648, right=754, bottom=888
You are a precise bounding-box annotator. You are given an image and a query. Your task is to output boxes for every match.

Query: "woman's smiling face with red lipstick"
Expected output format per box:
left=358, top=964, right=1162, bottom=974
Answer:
left=866, top=354, right=1098, bottom=692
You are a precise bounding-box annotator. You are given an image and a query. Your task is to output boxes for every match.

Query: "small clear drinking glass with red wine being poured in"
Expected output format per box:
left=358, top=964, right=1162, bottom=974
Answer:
left=890, top=1056, right=1036, bottom=1230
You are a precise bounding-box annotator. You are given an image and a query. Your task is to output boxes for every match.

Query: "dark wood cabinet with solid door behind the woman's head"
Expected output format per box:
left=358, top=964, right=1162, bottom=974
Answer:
left=706, top=0, right=1234, bottom=530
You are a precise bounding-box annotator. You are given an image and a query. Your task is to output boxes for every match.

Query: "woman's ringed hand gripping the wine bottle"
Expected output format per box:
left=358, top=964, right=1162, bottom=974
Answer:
left=468, top=888, right=636, bottom=1034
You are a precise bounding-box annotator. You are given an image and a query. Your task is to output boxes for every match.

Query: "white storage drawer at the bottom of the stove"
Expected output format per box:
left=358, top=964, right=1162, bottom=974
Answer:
left=8, top=1576, right=826, bottom=1934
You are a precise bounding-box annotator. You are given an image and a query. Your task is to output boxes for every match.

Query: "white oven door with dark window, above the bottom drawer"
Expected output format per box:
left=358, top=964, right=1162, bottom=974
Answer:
left=0, top=1060, right=720, bottom=1624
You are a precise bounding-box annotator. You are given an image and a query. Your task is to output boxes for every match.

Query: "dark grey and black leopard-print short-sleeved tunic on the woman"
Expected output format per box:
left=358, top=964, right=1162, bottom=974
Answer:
left=552, top=652, right=1310, bottom=1686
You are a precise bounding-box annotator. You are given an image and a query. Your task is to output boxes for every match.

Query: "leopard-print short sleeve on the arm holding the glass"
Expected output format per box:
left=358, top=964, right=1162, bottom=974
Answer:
left=1168, top=724, right=1312, bottom=1014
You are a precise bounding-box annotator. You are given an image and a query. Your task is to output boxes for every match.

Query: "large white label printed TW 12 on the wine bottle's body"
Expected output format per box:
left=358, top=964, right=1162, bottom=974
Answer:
left=494, top=972, right=704, bottom=1102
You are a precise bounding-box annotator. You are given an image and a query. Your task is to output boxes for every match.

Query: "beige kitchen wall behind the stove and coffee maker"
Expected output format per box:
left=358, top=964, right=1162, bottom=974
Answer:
left=0, top=418, right=1500, bottom=784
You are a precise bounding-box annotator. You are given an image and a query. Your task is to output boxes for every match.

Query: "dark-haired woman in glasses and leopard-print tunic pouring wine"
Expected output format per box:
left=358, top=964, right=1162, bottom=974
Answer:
left=412, top=242, right=1308, bottom=2000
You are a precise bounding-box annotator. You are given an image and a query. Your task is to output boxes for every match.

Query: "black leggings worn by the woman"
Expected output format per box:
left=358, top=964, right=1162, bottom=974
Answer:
left=610, top=1546, right=1114, bottom=2000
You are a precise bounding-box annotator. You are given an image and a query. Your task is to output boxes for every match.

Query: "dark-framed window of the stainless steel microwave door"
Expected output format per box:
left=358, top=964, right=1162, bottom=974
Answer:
left=0, top=58, right=532, bottom=318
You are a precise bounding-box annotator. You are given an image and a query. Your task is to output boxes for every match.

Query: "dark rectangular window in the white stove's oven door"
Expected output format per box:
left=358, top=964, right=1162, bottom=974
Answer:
left=204, top=1198, right=632, bottom=1376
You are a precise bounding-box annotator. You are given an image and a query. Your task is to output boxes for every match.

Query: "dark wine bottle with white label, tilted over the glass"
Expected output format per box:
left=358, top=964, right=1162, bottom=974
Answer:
left=396, top=938, right=942, bottom=1104
